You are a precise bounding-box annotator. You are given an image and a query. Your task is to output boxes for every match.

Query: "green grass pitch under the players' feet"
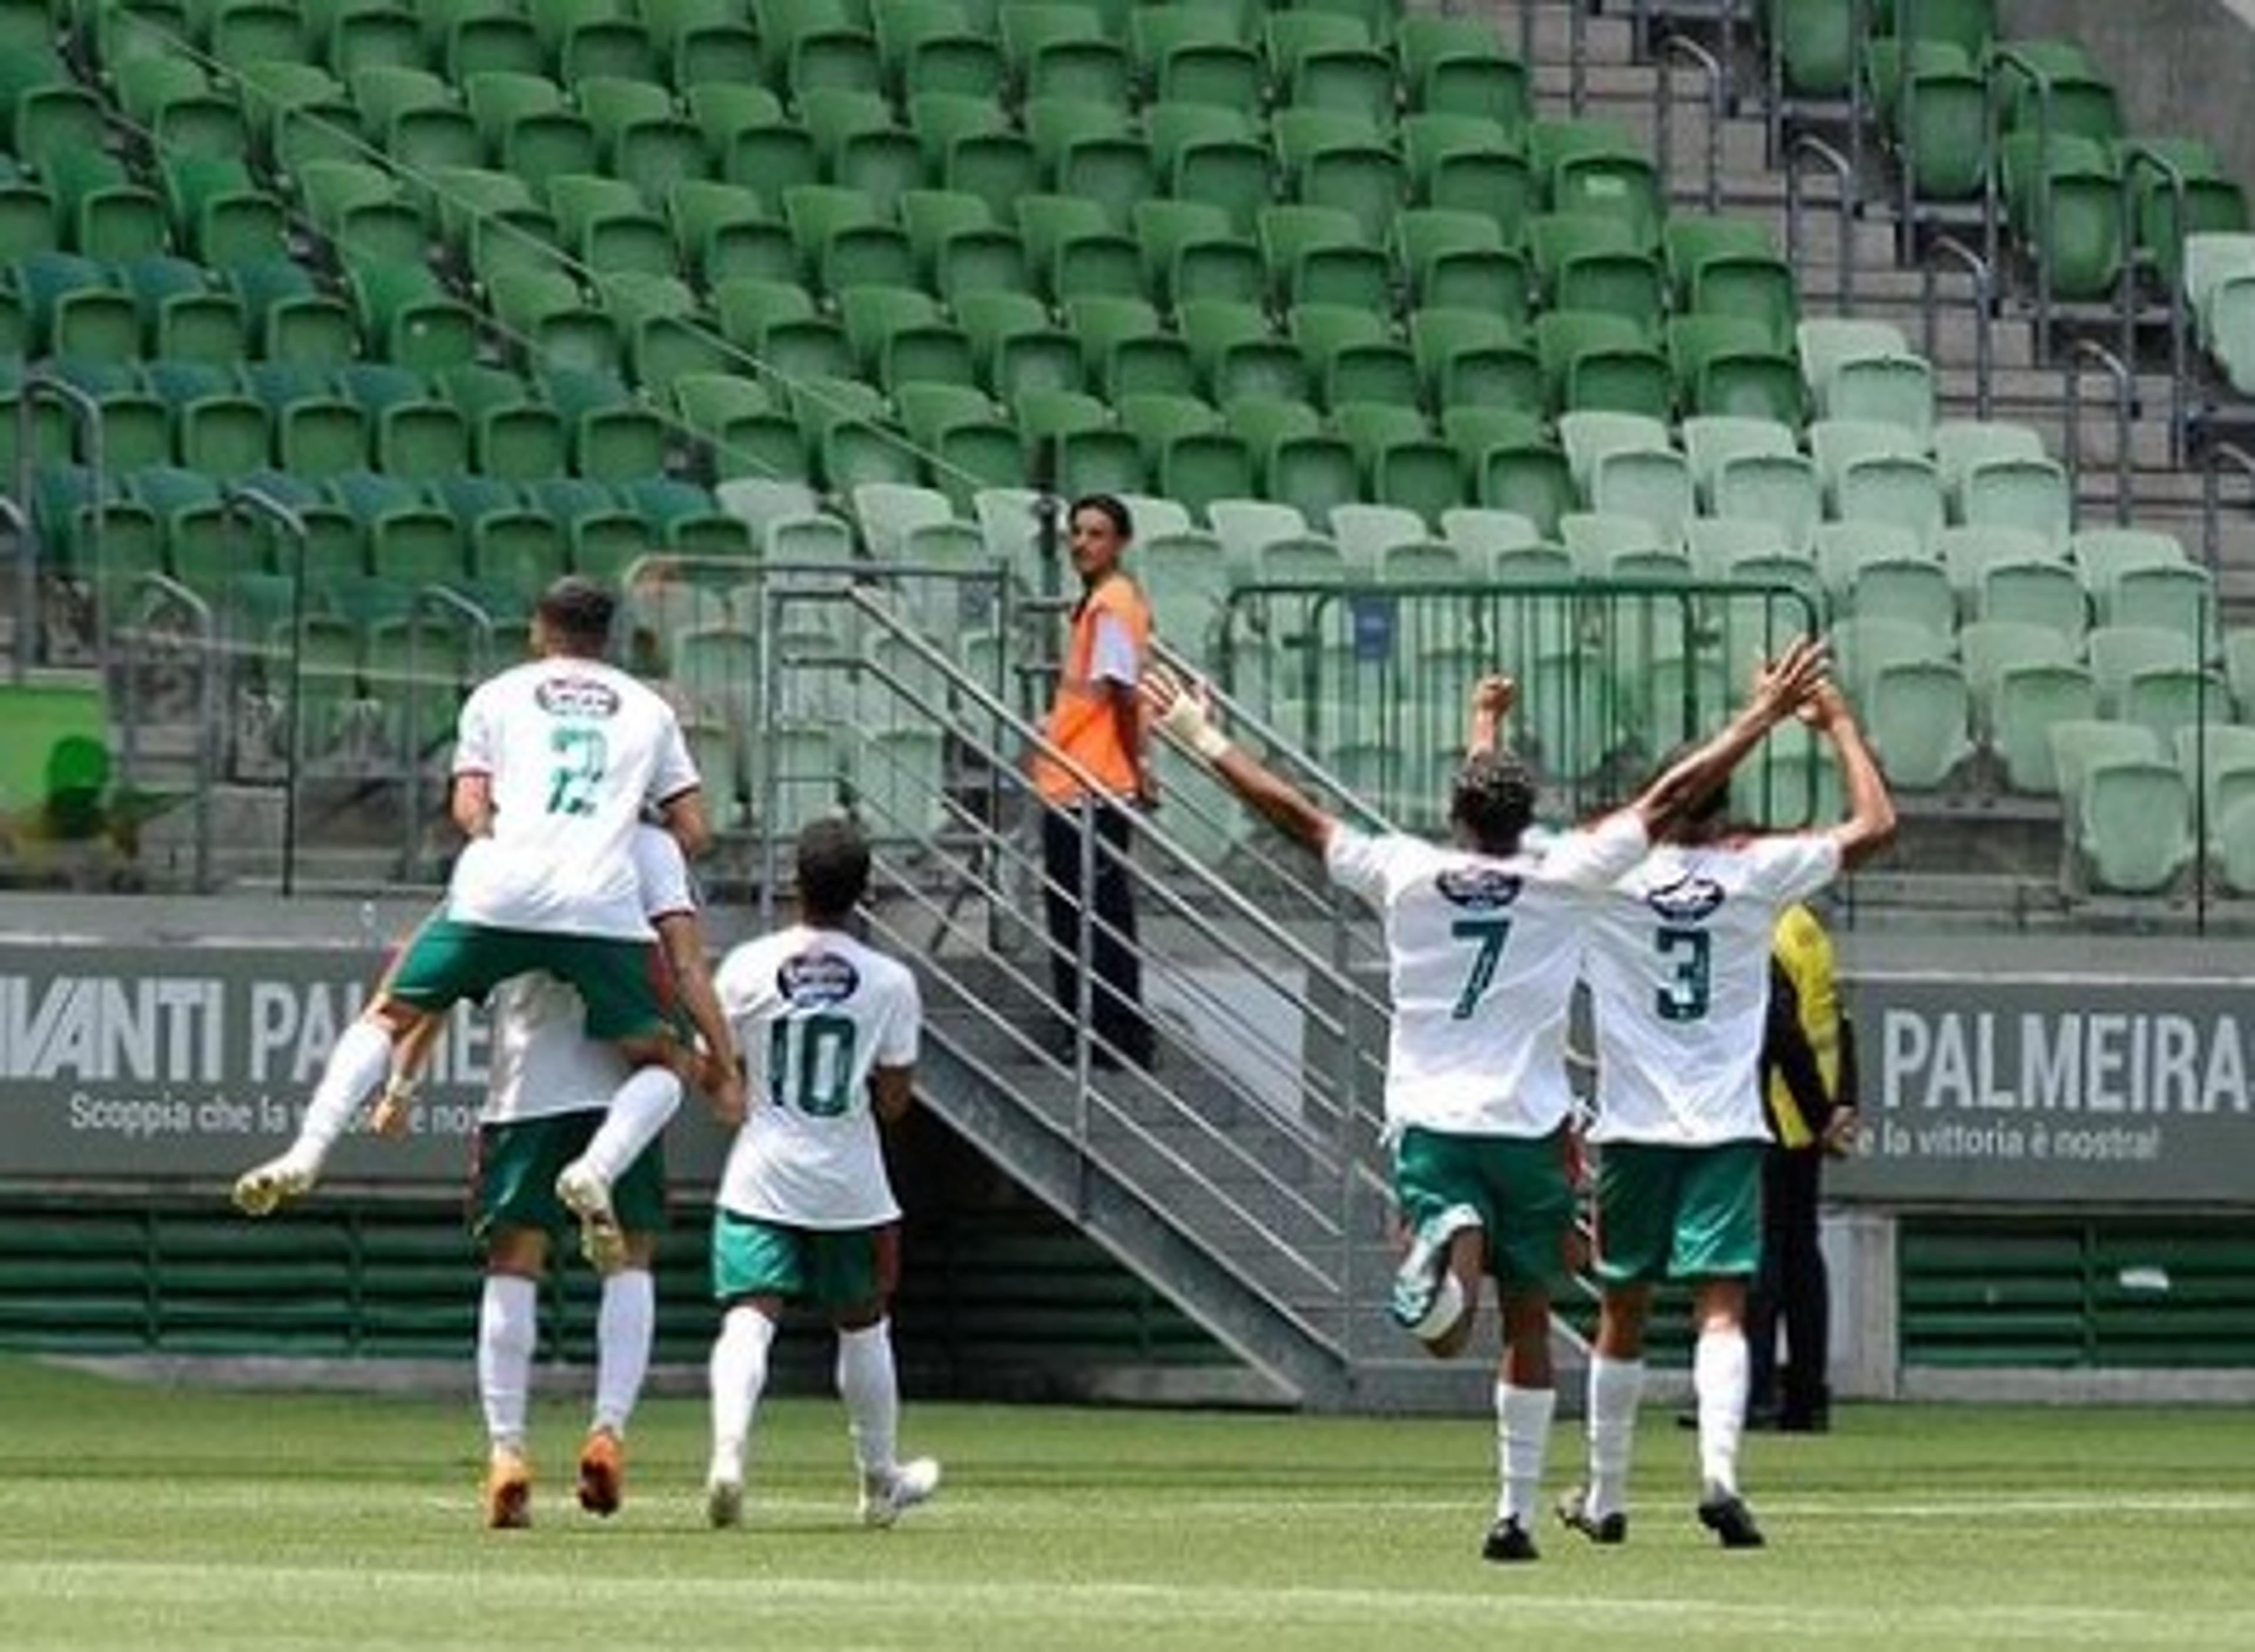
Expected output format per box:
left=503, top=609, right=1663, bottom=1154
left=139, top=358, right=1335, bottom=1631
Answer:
left=0, top=1364, right=2255, bottom=1652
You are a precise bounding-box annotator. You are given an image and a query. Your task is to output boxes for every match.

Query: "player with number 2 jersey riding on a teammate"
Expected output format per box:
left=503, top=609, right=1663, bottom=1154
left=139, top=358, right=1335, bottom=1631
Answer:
left=234, top=577, right=735, bottom=1230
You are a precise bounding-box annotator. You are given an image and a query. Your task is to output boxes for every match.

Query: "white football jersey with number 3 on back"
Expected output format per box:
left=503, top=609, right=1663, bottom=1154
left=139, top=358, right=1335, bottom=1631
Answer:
left=1586, top=832, right=1840, bottom=1147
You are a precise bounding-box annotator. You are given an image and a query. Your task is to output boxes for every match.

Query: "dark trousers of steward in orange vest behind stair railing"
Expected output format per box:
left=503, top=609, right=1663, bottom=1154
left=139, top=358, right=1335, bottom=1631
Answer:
left=1042, top=803, right=1152, bottom=1066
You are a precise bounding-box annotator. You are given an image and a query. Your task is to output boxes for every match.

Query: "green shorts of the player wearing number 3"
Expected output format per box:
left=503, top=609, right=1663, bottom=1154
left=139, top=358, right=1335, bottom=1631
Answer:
left=1597, top=1141, right=1768, bottom=1284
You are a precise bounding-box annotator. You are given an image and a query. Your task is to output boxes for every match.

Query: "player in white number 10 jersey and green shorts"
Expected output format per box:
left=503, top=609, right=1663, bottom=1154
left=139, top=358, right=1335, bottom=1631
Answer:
left=706, top=818, right=940, bottom=1526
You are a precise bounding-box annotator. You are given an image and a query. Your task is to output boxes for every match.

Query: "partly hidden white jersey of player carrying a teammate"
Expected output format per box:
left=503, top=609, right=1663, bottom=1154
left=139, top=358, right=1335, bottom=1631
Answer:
left=478, top=825, right=697, bottom=1125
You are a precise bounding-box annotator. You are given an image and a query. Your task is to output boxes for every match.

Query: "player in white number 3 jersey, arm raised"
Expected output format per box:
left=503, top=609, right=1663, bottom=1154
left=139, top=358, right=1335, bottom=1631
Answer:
left=1558, top=683, right=1894, bottom=1548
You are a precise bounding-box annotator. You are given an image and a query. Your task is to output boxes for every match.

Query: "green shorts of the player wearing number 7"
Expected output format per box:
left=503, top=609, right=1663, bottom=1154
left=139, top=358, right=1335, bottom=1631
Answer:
left=1394, top=1125, right=1574, bottom=1289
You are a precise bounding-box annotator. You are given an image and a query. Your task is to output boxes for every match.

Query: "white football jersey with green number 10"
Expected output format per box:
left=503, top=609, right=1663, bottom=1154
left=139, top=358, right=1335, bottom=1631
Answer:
left=712, top=924, right=923, bottom=1228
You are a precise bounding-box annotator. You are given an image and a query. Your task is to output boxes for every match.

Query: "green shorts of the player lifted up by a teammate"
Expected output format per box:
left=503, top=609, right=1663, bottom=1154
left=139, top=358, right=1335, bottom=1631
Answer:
left=386, top=917, right=674, bottom=1041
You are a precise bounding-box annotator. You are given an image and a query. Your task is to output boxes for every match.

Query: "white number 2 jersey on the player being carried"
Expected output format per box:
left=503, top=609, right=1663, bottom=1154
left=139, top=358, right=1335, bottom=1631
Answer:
left=446, top=656, right=697, bottom=940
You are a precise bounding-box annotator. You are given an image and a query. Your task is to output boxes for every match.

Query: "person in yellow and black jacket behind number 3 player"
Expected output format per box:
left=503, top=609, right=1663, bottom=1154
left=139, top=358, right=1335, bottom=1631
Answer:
left=1745, top=906, right=1856, bottom=1434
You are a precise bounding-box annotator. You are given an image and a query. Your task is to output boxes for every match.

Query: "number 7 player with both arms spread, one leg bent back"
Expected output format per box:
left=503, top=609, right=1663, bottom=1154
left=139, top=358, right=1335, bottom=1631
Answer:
left=1146, top=642, right=1822, bottom=1562
